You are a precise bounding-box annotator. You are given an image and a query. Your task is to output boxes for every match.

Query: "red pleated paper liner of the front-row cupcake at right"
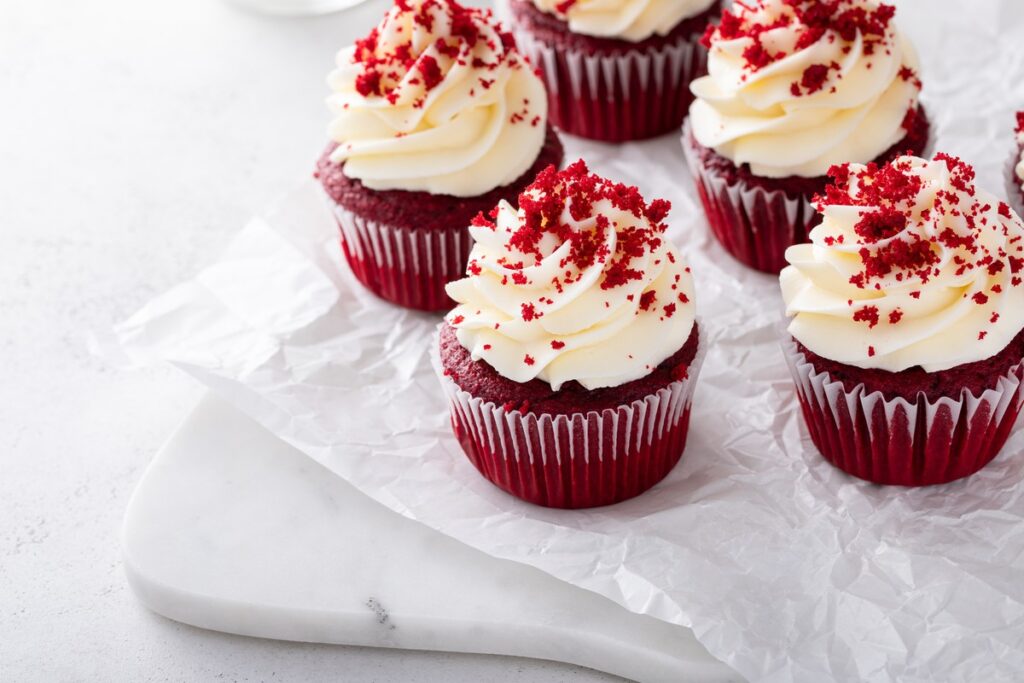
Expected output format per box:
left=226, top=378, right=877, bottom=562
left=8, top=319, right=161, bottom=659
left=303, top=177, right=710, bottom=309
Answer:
left=782, top=339, right=1024, bottom=486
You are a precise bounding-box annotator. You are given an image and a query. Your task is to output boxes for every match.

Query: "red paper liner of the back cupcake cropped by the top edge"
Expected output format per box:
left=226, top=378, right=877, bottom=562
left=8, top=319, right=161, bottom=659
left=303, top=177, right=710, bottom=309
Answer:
left=516, top=25, right=708, bottom=142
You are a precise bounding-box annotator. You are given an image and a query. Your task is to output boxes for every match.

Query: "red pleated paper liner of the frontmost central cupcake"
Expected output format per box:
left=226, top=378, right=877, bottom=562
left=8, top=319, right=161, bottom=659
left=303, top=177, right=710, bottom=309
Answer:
left=434, top=331, right=706, bottom=509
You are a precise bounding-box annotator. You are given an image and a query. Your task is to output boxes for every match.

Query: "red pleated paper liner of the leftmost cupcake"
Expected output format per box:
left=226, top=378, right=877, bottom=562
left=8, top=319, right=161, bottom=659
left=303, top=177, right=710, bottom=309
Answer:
left=329, top=199, right=473, bottom=311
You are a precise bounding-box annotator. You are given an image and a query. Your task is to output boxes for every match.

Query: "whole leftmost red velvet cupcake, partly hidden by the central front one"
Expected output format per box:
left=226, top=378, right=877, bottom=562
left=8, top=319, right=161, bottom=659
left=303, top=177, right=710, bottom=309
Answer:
left=316, top=0, right=562, bottom=310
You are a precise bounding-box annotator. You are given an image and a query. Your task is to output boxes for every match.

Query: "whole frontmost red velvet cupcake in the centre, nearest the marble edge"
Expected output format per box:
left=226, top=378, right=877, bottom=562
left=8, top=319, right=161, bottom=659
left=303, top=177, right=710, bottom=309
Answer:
left=435, top=161, right=703, bottom=508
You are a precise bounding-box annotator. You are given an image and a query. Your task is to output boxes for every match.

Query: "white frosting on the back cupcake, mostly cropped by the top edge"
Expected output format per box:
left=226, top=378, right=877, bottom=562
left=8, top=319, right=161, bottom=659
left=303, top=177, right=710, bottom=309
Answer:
left=532, top=0, right=718, bottom=43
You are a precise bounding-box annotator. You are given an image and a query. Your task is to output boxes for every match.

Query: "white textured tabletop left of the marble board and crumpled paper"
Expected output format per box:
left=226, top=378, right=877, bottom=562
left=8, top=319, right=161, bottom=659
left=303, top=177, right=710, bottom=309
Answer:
left=0, top=0, right=613, bottom=683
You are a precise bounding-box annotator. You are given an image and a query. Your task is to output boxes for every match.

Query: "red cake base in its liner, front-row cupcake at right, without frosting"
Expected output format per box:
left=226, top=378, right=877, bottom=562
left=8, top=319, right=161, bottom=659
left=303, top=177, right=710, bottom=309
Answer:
left=783, top=333, right=1024, bottom=486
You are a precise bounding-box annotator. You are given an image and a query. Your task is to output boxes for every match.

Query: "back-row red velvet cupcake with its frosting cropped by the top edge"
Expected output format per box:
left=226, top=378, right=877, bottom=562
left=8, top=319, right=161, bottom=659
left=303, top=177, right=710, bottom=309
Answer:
left=511, top=0, right=720, bottom=142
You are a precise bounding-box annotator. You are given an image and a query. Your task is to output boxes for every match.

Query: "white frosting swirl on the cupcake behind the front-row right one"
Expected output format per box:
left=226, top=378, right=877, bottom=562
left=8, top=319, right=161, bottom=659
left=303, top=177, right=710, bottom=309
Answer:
left=690, top=0, right=921, bottom=178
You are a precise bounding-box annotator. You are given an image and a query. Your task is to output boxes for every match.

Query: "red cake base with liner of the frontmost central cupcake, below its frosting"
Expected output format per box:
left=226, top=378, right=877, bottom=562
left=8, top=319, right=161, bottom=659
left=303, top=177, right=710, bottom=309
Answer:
left=437, top=324, right=703, bottom=509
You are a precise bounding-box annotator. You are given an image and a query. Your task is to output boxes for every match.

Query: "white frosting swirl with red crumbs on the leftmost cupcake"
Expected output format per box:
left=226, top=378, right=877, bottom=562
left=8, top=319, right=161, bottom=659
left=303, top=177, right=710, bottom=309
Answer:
left=327, top=0, right=548, bottom=197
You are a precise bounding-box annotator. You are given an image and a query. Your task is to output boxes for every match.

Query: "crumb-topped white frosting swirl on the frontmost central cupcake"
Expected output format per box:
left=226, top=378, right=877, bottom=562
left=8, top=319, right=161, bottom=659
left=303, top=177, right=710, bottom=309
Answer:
left=445, top=161, right=694, bottom=390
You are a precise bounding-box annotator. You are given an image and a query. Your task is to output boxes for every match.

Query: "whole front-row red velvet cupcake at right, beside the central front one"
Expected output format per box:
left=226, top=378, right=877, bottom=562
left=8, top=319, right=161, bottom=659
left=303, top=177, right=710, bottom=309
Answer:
left=780, top=155, right=1024, bottom=486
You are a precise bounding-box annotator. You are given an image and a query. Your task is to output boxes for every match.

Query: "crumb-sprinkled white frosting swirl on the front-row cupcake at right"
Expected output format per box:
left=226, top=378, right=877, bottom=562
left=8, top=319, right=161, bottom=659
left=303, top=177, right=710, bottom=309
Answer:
left=780, top=155, right=1024, bottom=373
